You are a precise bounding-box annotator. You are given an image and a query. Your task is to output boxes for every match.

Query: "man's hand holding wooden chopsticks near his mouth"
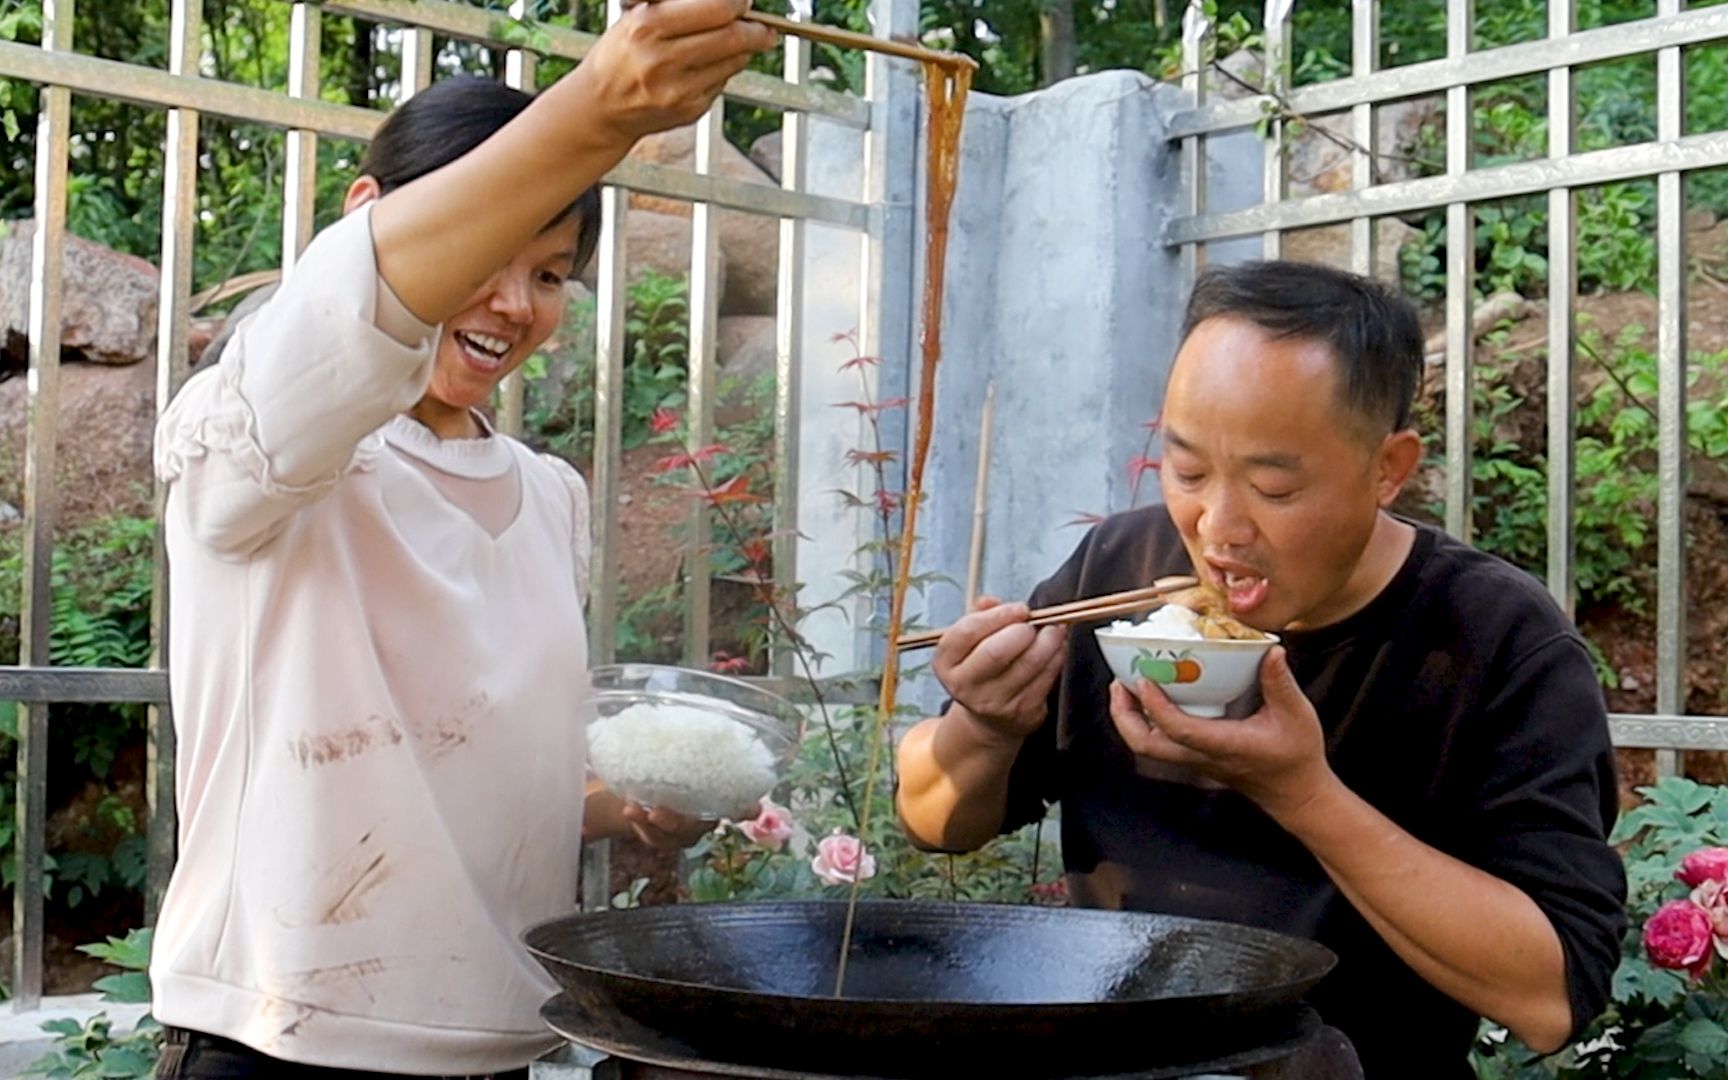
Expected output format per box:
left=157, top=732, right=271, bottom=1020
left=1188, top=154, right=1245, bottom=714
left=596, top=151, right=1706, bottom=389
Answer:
left=933, top=596, right=1068, bottom=743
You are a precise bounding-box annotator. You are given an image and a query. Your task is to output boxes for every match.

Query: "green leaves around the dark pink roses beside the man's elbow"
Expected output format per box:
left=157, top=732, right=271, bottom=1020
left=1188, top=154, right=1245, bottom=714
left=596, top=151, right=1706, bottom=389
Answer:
left=1474, top=778, right=1728, bottom=1080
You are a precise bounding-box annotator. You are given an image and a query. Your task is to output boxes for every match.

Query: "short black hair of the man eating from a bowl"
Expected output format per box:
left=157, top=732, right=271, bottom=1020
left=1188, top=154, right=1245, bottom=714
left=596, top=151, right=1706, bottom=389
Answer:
left=1182, top=261, right=1422, bottom=435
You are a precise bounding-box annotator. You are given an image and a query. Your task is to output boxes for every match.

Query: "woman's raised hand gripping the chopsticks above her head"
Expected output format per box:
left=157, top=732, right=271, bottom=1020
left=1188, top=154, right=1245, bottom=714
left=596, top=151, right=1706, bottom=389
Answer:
left=570, top=0, right=776, bottom=143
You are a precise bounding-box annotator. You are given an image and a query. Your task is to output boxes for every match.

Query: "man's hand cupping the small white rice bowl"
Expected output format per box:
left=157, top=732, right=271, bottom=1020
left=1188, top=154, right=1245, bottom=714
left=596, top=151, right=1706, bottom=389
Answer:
left=1109, top=646, right=1337, bottom=819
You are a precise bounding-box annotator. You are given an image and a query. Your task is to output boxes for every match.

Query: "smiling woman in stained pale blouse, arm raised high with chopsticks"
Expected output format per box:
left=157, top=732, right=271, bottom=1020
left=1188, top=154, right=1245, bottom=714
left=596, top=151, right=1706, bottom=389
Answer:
left=150, top=0, right=772, bottom=1077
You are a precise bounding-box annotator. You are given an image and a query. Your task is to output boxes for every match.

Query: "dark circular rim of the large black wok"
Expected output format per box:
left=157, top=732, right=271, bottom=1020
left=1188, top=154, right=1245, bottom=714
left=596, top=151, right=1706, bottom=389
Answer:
left=520, top=900, right=1337, bottom=1014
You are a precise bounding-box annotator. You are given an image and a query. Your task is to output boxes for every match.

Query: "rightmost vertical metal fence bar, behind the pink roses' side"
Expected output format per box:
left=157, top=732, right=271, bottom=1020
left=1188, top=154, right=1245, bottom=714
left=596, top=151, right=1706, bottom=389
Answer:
left=1655, top=0, right=1687, bottom=776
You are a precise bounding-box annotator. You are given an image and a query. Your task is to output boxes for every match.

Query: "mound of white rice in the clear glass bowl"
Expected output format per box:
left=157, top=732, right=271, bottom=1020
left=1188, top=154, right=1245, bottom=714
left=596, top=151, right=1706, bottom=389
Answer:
left=588, top=703, right=778, bottom=817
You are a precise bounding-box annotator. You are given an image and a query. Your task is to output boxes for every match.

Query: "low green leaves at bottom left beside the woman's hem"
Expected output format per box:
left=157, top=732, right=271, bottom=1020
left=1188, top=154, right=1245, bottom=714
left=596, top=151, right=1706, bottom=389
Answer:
left=22, top=928, right=162, bottom=1080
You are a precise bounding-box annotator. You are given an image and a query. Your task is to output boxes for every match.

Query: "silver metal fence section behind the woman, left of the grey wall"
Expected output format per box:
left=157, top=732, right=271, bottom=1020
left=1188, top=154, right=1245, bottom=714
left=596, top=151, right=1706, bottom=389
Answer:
left=0, top=0, right=916, bottom=1009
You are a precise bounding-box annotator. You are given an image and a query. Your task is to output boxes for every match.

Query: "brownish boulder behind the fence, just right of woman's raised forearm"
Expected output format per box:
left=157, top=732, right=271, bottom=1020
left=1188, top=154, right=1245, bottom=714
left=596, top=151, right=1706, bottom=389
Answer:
left=631, top=126, right=779, bottom=314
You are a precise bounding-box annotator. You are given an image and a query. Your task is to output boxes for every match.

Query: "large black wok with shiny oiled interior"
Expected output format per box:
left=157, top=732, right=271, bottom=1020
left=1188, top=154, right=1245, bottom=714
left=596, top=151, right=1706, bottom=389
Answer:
left=524, top=902, right=1334, bottom=1078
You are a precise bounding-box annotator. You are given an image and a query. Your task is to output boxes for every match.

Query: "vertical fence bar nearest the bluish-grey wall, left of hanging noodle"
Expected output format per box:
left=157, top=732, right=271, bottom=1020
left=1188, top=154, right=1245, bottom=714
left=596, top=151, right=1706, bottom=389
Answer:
left=769, top=14, right=810, bottom=677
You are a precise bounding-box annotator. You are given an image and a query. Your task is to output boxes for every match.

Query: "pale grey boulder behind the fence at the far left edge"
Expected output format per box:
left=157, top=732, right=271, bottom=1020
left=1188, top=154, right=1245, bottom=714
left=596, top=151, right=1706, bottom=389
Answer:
left=0, top=221, right=159, bottom=370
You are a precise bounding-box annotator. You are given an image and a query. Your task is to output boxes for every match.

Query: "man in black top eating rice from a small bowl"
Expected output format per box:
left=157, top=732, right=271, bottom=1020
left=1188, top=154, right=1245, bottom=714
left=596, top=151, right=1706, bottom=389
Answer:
left=897, top=263, right=1626, bottom=1080
